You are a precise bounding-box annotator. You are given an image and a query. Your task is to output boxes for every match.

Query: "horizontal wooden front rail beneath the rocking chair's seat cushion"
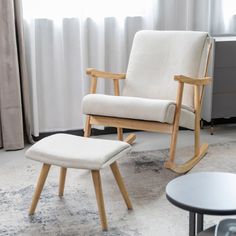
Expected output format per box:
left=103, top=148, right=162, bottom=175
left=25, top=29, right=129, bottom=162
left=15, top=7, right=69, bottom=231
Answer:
left=90, top=115, right=173, bottom=134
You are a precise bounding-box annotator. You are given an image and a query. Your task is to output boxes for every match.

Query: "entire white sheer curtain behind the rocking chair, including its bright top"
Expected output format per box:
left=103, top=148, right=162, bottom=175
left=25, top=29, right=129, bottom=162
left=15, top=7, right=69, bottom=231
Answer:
left=23, top=0, right=235, bottom=136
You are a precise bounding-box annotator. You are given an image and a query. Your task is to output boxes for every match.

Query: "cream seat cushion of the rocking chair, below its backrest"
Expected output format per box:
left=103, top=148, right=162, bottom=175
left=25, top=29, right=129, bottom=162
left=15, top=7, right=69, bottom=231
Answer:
left=83, top=94, right=195, bottom=129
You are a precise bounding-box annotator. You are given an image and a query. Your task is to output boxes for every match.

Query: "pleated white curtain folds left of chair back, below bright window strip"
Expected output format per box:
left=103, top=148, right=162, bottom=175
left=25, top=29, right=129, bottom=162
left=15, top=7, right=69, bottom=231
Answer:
left=25, top=17, right=156, bottom=136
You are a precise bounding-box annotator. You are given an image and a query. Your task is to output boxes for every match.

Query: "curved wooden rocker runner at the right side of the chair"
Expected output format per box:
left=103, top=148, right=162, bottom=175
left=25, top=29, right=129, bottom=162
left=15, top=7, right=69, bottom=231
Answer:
left=165, top=143, right=208, bottom=174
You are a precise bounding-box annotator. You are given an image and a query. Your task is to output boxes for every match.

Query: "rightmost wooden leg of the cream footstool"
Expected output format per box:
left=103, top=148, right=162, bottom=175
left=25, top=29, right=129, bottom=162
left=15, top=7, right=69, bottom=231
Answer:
left=110, top=162, right=133, bottom=210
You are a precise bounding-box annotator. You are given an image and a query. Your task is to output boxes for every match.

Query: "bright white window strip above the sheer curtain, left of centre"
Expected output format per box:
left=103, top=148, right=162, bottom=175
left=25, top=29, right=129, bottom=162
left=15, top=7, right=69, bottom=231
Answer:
left=23, top=0, right=150, bottom=18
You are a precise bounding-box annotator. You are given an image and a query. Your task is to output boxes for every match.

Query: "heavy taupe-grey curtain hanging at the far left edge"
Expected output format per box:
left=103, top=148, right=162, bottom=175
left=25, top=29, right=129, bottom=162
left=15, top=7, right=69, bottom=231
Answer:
left=0, top=0, right=33, bottom=150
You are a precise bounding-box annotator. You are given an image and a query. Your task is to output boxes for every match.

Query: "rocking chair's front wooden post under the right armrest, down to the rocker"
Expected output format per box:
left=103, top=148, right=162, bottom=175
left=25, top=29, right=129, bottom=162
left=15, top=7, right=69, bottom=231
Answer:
left=165, top=82, right=184, bottom=165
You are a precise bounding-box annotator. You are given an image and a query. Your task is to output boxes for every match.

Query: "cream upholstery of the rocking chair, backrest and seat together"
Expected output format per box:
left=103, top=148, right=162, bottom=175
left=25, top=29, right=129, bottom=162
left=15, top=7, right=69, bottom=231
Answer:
left=83, top=30, right=210, bottom=129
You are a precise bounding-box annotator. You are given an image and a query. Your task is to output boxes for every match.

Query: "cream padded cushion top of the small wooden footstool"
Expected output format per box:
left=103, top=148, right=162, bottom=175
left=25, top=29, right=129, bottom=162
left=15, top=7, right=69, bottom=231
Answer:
left=25, top=134, right=131, bottom=170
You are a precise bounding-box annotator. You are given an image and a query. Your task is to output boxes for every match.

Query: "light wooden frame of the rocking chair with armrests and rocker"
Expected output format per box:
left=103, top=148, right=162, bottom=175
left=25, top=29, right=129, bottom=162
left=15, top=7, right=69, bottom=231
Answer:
left=84, top=44, right=212, bottom=173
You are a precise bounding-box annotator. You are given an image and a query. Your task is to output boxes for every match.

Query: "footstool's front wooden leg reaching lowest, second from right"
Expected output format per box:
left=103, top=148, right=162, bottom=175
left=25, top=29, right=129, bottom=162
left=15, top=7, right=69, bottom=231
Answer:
left=91, top=170, right=107, bottom=230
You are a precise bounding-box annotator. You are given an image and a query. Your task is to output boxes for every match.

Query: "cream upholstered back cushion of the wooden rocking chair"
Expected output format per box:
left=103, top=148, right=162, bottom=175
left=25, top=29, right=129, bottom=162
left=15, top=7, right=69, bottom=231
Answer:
left=122, top=30, right=207, bottom=107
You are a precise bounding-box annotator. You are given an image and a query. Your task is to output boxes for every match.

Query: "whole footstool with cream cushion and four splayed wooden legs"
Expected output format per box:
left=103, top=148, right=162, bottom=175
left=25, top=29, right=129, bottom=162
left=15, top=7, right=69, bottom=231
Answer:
left=25, top=134, right=132, bottom=230
